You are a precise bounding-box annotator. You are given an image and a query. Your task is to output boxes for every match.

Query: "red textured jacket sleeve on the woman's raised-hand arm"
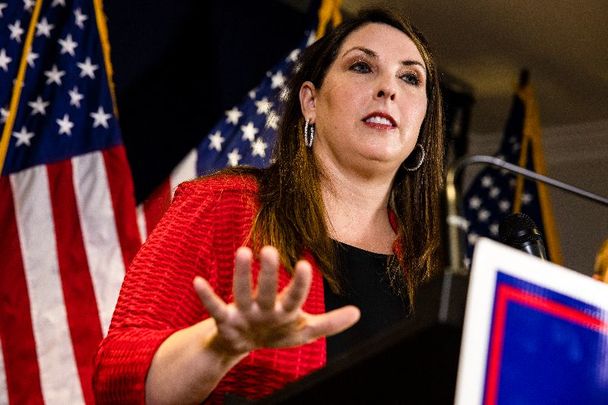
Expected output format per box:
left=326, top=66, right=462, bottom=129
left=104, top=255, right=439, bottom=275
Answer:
left=93, top=175, right=250, bottom=403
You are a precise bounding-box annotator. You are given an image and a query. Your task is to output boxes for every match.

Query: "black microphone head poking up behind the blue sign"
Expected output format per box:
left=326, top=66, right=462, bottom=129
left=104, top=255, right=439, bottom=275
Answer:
left=498, top=213, right=547, bottom=260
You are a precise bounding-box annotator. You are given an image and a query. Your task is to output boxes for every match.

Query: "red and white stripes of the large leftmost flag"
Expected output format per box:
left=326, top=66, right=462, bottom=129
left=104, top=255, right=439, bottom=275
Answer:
left=0, top=146, right=139, bottom=404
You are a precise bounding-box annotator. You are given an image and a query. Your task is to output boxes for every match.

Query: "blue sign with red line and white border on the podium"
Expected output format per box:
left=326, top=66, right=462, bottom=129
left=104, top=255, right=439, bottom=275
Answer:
left=455, top=238, right=608, bottom=405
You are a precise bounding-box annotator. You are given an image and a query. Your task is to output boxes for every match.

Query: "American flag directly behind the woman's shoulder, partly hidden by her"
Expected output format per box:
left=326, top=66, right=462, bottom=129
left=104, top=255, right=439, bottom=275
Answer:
left=138, top=31, right=315, bottom=235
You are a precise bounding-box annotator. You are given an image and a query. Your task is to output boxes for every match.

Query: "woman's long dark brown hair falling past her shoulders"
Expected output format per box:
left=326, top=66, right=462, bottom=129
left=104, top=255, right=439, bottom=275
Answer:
left=224, top=9, right=444, bottom=304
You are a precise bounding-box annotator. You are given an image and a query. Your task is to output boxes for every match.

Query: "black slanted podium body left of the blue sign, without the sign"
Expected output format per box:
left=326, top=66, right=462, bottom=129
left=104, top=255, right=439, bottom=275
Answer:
left=254, top=268, right=468, bottom=405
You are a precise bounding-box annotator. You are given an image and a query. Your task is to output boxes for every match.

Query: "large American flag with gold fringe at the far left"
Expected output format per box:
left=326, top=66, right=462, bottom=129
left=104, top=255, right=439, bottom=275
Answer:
left=0, top=0, right=141, bottom=404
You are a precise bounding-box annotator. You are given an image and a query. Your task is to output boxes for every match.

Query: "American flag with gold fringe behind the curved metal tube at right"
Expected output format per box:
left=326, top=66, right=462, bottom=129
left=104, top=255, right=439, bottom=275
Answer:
left=462, top=83, right=561, bottom=267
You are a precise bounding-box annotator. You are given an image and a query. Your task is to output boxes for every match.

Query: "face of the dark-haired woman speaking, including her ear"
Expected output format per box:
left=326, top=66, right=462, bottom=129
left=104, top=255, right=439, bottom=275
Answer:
left=300, top=23, right=427, bottom=178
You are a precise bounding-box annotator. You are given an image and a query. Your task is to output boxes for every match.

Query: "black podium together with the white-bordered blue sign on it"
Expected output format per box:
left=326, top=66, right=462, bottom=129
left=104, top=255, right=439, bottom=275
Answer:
left=240, top=238, right=608, bottom=405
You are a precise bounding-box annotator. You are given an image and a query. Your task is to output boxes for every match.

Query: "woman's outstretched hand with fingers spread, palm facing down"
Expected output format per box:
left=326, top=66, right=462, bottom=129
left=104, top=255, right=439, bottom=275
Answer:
left=194, top=246, right=360, bottom=355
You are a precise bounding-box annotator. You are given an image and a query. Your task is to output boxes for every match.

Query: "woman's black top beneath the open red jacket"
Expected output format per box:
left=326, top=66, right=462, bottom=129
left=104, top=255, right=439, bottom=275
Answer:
left=324, top=243, right=409, bottom=362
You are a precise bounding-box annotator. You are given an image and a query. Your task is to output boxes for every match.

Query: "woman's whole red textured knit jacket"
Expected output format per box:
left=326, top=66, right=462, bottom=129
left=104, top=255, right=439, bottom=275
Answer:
left=93, top=175, right=326, bottom=403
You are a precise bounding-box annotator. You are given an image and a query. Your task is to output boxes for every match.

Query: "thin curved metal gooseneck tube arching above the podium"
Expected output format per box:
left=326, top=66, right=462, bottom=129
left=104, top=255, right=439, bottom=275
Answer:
left=446, top=155, right=608, bottom=274
